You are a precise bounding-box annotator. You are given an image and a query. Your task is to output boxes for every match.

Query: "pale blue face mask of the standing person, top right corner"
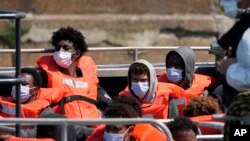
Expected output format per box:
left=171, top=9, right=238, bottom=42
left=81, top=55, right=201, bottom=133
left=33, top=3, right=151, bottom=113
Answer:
left=220, top=0, right=238, bottom=18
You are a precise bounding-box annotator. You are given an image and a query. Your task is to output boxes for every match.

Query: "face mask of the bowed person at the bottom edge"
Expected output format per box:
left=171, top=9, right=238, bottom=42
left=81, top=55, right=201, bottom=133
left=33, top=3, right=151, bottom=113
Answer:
left=103, top=127, right=130, bottom=141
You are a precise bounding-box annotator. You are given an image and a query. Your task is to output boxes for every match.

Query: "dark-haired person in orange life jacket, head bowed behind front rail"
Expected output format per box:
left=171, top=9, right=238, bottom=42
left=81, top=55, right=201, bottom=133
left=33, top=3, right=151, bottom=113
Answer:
left=86, top=96, right=167, bottom=141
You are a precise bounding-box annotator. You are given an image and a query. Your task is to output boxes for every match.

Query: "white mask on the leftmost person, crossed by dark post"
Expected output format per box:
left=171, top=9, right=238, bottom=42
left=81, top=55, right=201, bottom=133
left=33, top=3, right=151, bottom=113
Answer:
left=11, top=85, right=31, bottom=103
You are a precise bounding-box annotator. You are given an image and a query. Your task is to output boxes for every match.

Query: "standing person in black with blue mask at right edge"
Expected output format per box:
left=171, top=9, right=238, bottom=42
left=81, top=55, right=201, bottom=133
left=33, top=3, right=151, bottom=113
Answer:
left=210, top=0, right=250, bottom=108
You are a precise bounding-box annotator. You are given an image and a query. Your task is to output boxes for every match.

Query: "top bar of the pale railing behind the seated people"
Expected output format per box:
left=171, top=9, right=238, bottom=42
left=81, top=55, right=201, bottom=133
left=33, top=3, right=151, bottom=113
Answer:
left=0, top=46, right=210, bottom=53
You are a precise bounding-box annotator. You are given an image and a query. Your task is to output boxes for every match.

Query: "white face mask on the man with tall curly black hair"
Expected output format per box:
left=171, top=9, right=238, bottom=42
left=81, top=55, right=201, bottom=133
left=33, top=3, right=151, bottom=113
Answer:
left=54, top=51, right=73, bottom=68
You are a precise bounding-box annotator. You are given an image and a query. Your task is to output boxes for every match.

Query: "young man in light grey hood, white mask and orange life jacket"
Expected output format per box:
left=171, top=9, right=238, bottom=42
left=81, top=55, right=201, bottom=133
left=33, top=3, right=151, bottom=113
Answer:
left=119, top=59, right=184, bottom=119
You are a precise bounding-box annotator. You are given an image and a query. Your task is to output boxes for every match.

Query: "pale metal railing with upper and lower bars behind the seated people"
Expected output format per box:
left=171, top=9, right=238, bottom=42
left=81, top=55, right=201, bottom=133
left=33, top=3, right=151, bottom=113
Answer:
left=0, top=46, right=215, bottom=77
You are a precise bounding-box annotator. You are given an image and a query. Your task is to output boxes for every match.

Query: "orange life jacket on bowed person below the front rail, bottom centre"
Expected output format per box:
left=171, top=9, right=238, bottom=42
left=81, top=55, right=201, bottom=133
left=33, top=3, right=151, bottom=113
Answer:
left=86, top=124, right=167, bottom=141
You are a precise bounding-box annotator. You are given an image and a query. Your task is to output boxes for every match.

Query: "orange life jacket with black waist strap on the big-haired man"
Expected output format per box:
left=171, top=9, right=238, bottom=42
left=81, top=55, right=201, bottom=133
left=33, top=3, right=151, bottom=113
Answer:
left=37, top=56, right=100, bottom=118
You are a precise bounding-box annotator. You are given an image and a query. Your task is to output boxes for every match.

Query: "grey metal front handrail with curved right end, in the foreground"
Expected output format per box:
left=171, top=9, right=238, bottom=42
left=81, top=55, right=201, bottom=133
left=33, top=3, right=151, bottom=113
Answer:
left=0, top=118, right=172, bottom=141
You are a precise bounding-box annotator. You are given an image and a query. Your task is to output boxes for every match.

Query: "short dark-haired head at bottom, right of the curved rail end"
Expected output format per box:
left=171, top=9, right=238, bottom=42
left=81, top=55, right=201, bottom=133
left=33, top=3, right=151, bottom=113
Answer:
left=167, top=116, right=199, bottom=141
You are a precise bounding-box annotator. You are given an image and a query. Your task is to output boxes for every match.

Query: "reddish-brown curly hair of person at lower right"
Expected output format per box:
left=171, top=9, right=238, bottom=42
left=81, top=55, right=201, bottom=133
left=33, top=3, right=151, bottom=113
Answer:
left=183, top=96, right=220, bottom=117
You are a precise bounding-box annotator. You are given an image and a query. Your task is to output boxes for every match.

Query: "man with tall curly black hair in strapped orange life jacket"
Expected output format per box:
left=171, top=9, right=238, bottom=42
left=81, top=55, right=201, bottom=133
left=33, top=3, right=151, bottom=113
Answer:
left=37, top=27, right=101, bottom=118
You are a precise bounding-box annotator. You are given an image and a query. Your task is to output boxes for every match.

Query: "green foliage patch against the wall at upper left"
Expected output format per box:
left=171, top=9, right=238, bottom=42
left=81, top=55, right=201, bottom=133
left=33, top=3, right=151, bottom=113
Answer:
left=0, top=22, right=30, bottom=49
